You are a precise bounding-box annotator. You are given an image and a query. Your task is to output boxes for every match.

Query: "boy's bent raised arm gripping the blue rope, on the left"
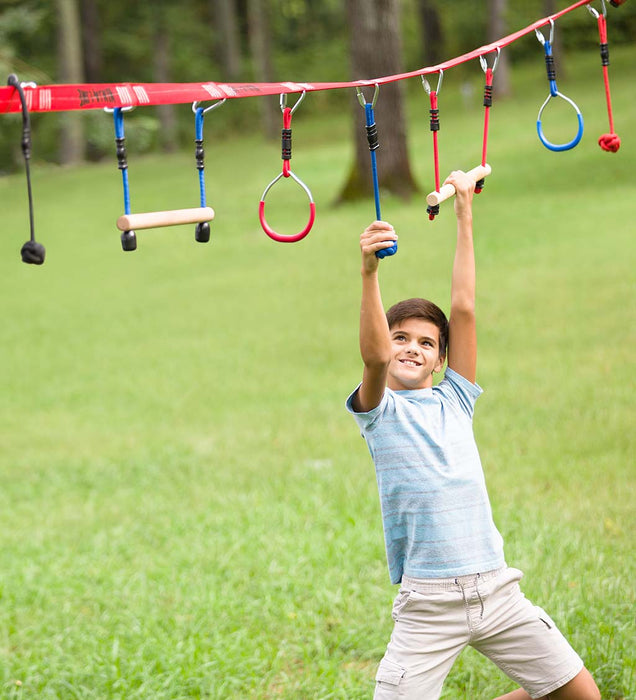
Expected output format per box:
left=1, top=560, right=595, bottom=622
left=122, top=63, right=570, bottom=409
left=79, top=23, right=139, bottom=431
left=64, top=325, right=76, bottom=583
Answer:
left=353, top=221, right=397, bottom=412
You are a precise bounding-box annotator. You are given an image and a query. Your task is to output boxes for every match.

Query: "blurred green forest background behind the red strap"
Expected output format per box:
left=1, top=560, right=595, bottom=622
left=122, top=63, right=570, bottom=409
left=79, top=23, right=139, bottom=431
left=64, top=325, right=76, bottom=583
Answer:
left=0, top=0, right=636, bottom=172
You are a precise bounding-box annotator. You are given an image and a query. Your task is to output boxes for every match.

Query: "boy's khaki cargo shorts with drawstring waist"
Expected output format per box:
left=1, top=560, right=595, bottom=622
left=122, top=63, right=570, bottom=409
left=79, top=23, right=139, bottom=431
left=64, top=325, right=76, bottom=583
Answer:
left=374, top=568, right=583, bottom=700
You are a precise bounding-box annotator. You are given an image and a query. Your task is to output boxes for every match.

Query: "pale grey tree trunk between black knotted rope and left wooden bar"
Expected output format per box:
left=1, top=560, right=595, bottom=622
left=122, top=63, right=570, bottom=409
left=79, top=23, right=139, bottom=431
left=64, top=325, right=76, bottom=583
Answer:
left=56, top=0, right=85, bottom=165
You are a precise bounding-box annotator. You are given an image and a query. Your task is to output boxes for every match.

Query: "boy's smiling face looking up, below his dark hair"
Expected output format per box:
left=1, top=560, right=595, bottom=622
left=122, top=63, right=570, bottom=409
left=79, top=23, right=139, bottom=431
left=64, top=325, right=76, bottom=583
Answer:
left=387, top=318, right=444, bottom=391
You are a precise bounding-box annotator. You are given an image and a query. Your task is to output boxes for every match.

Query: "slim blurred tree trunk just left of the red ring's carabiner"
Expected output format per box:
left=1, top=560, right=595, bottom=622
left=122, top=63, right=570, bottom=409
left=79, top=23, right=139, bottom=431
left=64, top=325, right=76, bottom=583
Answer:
left=247, top=0, right=282, bottom=139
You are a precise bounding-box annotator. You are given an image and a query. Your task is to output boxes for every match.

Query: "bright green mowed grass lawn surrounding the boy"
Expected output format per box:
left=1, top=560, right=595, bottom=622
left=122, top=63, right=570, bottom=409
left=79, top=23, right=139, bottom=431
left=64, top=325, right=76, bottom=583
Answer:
left=0, top=48, right=636, bottom=700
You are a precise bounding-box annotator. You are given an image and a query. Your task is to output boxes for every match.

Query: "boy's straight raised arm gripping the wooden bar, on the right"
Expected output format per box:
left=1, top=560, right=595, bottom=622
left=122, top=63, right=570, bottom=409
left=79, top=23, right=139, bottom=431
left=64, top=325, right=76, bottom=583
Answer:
left=446, top=171, right=477, bottom=383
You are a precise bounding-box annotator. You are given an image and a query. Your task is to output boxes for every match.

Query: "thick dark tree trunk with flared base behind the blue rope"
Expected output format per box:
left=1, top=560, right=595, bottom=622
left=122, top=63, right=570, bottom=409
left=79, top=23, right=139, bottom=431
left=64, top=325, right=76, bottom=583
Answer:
left=338, top=0, right=418, bottom=202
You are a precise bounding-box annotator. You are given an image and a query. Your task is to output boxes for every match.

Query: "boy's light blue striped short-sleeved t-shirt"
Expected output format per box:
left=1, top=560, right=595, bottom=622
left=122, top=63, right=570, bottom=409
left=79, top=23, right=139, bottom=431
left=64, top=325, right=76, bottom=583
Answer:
left=346, top=368, right=505, bottom=583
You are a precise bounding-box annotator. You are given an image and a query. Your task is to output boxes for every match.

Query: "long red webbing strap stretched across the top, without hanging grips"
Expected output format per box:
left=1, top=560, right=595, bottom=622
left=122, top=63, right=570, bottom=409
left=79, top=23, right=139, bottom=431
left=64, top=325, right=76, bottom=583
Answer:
left=0, top=0, right=590, bottom=113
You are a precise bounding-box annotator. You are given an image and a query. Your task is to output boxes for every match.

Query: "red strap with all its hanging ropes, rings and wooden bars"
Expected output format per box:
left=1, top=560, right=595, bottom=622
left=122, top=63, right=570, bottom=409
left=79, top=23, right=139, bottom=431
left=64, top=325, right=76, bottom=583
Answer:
left=0, top=0, right=626, bottom=265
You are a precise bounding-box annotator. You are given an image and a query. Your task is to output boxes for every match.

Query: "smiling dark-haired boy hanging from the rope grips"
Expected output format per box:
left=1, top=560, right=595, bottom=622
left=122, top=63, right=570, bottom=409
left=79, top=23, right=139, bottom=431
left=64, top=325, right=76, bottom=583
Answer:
left=347, top=171, right=600, bottom=700
